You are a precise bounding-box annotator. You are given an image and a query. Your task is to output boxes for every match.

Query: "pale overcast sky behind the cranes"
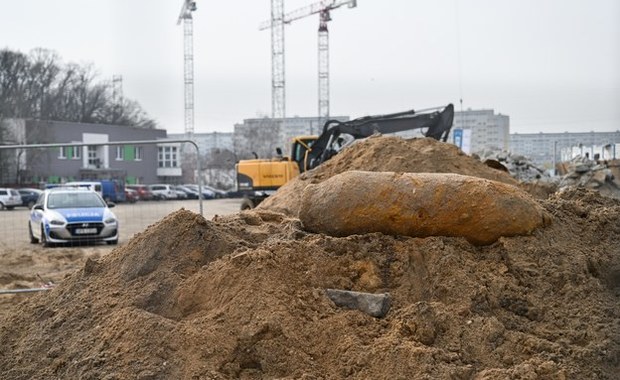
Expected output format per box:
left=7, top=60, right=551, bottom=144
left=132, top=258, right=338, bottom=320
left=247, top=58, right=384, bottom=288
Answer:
left=0, top=0, right=620, bottom=133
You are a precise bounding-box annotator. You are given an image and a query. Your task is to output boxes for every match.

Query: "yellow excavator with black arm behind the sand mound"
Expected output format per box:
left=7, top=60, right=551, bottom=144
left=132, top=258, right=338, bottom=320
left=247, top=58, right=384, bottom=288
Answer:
left=235, top=104, right=454, bottom=210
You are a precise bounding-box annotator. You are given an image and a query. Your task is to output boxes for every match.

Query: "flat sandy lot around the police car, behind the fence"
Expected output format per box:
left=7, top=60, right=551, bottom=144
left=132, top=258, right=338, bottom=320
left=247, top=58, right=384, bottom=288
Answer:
left=0, top=199, right=241, bottom=315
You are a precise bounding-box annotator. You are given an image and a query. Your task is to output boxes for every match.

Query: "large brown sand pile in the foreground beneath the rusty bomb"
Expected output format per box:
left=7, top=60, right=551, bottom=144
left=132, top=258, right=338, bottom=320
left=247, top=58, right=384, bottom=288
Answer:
left=0, top=139, right=620, bottom=379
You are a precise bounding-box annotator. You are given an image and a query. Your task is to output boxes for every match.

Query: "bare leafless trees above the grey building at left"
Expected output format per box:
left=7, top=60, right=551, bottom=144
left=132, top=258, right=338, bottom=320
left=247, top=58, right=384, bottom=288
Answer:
left=0, top=49, right=156, bottom=128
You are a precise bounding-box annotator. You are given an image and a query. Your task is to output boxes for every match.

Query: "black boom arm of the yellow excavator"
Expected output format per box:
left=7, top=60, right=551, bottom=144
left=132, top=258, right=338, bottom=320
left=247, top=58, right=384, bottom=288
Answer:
left=306, top=104, right=454, bottom=171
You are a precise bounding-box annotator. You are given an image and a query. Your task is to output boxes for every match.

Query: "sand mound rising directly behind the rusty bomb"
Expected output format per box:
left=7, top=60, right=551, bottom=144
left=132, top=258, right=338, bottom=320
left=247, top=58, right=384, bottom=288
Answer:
left=258, top=135, right=527, bottom=216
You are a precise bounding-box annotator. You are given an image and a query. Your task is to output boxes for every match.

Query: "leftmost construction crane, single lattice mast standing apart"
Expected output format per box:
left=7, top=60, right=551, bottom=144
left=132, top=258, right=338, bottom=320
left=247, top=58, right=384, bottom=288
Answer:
left=177, top=0, right=196, bottom=139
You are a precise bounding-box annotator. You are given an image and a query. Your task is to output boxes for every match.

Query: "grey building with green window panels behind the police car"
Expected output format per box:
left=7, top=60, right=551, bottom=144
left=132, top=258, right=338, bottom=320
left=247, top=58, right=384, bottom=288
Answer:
left=3, top=119, right=182, bottom=184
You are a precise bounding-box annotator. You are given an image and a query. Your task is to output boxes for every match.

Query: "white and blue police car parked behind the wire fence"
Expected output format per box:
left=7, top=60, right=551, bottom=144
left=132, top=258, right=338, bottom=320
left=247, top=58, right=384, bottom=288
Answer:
left=28, top=187, right=119, bottom=246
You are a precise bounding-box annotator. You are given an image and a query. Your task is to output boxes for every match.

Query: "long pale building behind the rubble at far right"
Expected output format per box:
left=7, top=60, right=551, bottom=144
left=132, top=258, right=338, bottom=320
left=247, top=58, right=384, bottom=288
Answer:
left=510, top=131, right=620, bottom=168
